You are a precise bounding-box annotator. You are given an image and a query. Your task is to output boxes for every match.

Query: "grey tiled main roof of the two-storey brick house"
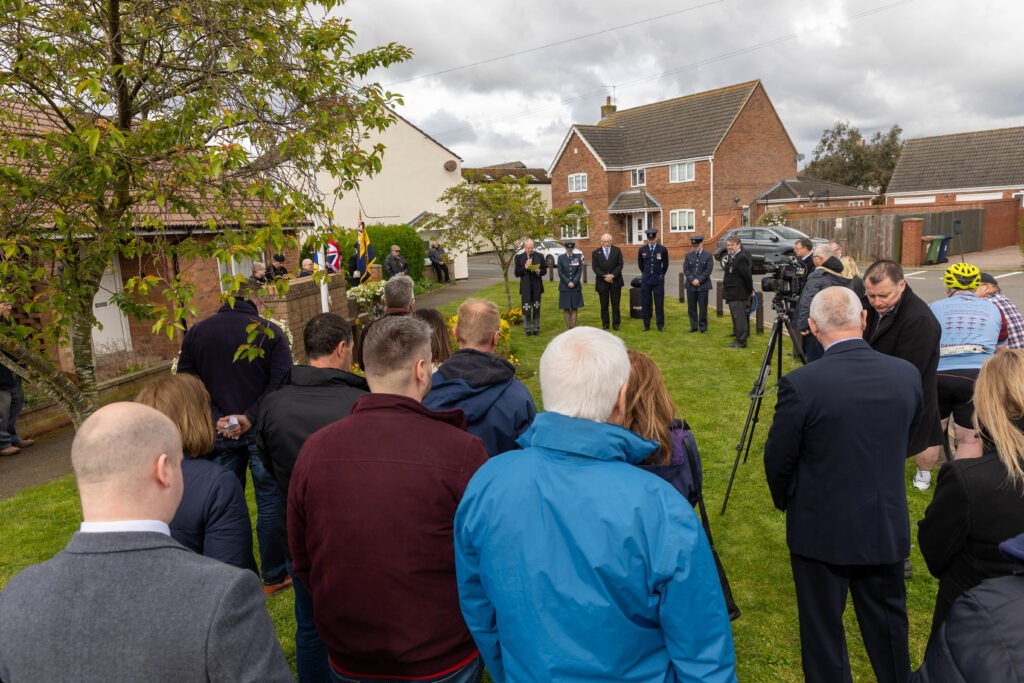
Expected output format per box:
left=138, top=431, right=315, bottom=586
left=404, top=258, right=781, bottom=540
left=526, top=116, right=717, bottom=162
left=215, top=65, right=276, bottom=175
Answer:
left=575, top=81, right=760, bottom=167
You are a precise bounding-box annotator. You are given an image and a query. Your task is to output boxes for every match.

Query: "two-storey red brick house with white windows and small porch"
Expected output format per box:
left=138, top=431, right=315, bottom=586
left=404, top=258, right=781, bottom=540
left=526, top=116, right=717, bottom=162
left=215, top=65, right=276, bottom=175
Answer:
left=549, top=81, right=797, bottom=255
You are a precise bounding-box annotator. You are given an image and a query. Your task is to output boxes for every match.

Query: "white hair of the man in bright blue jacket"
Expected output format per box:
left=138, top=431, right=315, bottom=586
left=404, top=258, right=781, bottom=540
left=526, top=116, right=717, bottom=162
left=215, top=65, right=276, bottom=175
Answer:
left=540, top=327, right=630, bottom=422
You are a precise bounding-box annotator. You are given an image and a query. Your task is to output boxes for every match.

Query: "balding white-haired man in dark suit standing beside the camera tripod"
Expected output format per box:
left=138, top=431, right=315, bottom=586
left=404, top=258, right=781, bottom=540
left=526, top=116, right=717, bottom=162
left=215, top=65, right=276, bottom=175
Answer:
left=764, top=287, right=922, bottom=683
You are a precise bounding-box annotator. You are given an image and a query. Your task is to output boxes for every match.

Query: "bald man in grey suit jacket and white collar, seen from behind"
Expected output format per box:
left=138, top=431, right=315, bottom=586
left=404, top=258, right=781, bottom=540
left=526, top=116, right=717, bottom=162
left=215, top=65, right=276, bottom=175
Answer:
left=0, top=403, right=294, bottom=681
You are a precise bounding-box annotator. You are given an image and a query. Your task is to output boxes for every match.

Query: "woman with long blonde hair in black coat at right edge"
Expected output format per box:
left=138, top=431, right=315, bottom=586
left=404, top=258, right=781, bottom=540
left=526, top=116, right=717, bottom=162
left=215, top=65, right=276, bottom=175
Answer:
left=918, top=350, right=1024, bottom=638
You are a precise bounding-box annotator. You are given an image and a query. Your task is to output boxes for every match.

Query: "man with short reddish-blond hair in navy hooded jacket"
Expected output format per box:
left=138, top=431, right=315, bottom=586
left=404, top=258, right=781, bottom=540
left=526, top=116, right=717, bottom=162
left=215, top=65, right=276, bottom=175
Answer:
left=423, top=299, right=537, bottom=458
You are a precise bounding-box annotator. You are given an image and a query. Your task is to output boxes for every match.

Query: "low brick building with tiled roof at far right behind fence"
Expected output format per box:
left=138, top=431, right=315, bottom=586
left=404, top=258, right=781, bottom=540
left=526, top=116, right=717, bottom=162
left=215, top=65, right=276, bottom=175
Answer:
left=886, top=127, right=1024, bottom=249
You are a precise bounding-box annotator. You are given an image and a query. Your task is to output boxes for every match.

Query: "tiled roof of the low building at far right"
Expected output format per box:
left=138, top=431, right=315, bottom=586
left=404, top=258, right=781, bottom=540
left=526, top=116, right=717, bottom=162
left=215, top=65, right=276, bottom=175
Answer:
left=888, top=127, right=1024, bottom=194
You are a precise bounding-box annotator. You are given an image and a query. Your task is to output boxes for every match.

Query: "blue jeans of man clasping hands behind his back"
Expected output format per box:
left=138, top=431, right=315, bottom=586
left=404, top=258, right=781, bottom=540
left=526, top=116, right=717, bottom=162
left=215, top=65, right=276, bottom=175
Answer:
left=213, top=430, right=288, bottom=585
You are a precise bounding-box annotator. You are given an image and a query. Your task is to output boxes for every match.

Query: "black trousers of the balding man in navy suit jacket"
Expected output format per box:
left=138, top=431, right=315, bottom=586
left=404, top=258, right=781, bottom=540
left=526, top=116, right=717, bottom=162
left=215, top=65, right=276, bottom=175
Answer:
left=790, top=553, right=910, bottom=683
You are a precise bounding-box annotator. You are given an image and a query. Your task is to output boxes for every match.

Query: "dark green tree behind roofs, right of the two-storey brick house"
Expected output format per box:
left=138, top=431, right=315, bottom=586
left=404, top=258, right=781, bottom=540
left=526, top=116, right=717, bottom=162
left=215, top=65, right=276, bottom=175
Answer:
left=804, top=121, right=903, bottom=195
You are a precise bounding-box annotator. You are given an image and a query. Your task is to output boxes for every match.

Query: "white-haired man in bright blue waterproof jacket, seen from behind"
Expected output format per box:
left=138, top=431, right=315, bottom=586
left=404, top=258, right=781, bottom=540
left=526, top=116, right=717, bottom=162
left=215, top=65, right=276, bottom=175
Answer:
left=455, top=327, right=736, bottom=683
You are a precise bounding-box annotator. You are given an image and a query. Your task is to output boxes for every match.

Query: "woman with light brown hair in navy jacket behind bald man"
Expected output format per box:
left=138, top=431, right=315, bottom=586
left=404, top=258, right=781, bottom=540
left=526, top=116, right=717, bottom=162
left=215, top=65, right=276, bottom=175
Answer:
left=135, top=374, right=256, bottom=571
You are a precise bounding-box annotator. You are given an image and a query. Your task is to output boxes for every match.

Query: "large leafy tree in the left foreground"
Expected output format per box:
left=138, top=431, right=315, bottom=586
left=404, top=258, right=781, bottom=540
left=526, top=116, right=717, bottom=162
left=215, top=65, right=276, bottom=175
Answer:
left=0, top=0, right=411, bottom=426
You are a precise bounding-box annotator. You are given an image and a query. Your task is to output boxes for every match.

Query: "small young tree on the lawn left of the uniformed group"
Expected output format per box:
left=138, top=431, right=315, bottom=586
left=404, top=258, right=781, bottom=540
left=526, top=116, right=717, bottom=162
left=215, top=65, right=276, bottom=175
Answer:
left=430, top=178, right=551, bottom=310
